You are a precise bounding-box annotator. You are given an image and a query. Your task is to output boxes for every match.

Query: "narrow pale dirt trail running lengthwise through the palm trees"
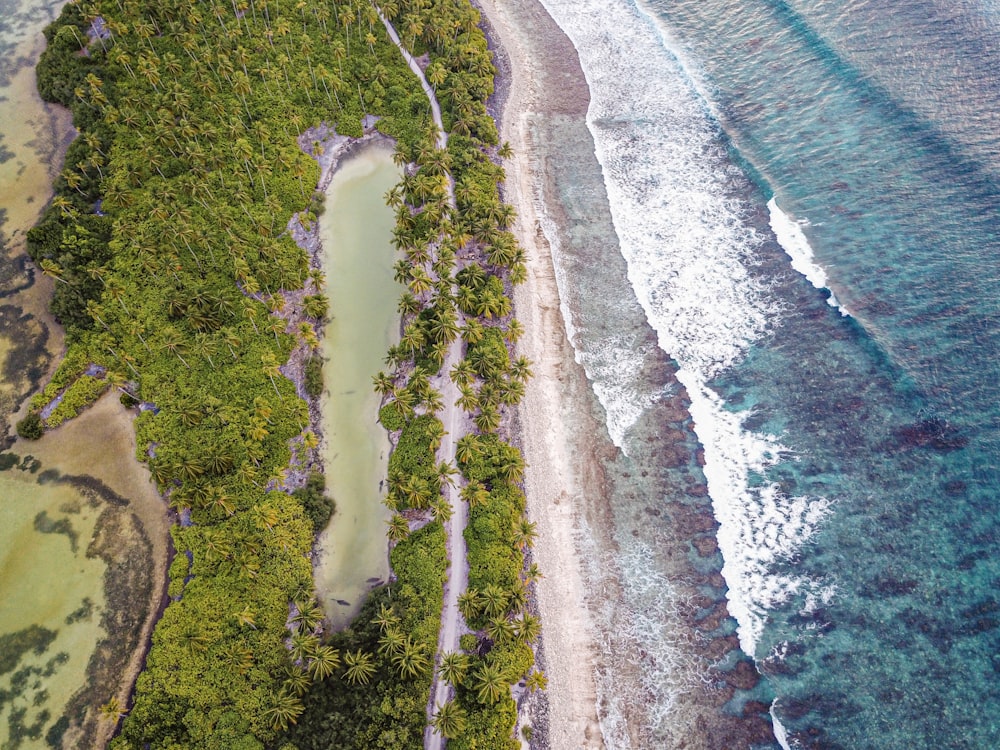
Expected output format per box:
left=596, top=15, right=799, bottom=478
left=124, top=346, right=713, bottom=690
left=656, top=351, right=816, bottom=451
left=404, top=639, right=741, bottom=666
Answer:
left=375, top=6, right=469, bottom=750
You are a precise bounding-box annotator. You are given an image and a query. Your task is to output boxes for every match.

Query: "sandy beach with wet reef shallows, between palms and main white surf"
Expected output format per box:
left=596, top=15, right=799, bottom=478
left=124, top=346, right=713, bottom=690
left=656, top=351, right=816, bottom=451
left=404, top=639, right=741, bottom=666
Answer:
left=477, top=0, right=773, bottom=750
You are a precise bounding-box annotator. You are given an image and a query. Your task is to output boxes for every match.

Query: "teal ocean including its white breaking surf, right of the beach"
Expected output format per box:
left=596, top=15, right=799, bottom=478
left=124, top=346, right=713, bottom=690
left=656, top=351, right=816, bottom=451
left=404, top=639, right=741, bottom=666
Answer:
left=542, top=0, right=1000, bottom=749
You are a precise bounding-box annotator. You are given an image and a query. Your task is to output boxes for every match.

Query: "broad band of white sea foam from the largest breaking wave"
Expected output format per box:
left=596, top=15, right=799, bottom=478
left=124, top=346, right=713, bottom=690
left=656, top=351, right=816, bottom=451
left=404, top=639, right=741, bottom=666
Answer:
left=542, top=0, right=828, bottom=654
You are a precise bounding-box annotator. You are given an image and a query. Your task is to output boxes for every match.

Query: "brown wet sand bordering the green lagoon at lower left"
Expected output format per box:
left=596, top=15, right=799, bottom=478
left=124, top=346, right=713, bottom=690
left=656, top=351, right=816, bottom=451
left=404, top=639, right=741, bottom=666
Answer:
left=12, top=391, right=172, bottom=747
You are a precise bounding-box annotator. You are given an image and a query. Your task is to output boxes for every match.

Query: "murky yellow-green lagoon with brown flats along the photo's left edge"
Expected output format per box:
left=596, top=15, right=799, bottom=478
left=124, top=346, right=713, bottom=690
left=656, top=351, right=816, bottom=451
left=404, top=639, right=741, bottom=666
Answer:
left=0, top=0, right=167, bottom=749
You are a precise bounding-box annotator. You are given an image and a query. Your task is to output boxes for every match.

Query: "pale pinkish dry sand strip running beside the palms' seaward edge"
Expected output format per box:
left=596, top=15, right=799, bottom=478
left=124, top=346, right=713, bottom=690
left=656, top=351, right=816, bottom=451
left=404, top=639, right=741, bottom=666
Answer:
left=476, top=0, right=606, bottom=749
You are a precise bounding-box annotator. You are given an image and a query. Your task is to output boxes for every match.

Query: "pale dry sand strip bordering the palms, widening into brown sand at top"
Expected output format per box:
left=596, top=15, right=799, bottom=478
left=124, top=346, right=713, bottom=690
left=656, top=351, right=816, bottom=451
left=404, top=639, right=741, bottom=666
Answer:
left=477, top=0, right=605, bottom=750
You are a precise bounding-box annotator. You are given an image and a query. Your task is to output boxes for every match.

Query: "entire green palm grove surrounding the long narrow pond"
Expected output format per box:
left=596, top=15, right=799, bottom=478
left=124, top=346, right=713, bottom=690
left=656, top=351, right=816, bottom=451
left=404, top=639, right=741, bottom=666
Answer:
left=31, top=0, right=544, bottom=750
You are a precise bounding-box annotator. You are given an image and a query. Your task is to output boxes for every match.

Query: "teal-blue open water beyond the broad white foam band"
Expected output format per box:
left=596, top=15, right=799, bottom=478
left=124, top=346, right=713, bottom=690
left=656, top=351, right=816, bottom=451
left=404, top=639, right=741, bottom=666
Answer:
left=649, top=0, right=1000, bottom=748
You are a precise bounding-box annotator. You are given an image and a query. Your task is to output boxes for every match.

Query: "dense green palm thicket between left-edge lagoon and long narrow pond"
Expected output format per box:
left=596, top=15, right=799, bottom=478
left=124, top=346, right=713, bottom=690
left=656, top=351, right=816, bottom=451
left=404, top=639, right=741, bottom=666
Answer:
left=29, top=0, right=438, bottom=748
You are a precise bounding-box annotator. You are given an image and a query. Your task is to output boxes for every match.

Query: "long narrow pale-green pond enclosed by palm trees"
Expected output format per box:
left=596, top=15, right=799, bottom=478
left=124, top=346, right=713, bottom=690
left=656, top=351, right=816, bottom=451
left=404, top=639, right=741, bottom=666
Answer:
left=315, top=146, right=403, bottom=627
